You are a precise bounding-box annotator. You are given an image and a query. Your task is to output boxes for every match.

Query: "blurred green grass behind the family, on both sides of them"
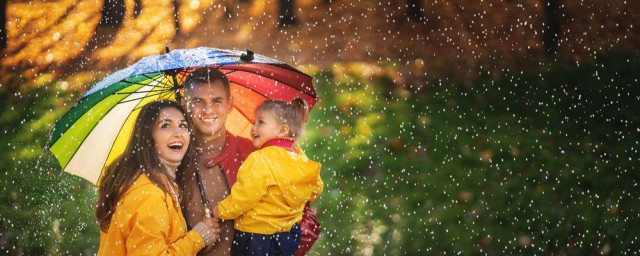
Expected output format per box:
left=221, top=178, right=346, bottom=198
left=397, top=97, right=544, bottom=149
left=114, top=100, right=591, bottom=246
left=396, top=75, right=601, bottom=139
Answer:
left=0, top=52, right=640, bottom=255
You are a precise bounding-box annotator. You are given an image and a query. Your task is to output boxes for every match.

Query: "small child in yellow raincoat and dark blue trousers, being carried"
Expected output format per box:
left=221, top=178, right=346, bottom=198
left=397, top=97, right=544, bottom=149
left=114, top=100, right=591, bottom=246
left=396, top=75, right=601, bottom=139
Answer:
left=213, top=99, right=323, bottom=256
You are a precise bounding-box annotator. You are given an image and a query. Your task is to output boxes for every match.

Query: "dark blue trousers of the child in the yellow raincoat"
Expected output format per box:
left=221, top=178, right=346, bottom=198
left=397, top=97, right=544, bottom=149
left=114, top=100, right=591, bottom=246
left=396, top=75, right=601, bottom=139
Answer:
left=231, top=224, right=300, bottom=256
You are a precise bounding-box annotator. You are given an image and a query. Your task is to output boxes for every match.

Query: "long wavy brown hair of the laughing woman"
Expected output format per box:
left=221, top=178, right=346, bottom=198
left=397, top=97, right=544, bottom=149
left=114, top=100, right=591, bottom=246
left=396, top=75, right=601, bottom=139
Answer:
left=96, top=100, right=196, bottom=232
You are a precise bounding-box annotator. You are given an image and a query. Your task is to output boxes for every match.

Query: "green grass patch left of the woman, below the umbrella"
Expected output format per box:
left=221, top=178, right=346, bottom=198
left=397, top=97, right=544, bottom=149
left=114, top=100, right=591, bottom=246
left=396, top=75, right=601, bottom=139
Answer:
left=0, top=84, right=99, bottom=255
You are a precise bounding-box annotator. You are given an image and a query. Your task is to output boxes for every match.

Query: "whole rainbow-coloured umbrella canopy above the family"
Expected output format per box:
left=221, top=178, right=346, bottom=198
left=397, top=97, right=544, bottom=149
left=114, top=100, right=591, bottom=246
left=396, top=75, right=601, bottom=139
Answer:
left=48, top=47, right=317, bottom=184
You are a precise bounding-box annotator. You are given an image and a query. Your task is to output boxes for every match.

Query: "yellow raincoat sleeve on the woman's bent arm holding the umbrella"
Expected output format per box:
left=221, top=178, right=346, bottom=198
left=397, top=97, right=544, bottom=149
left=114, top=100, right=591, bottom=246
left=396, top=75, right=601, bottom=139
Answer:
left=126, top=193, right=205, bottom=255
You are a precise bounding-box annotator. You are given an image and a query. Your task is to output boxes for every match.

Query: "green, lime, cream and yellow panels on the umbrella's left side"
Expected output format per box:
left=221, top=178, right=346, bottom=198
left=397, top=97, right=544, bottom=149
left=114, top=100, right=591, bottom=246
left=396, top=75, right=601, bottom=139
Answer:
left=49, top=73, right=175, bottom=184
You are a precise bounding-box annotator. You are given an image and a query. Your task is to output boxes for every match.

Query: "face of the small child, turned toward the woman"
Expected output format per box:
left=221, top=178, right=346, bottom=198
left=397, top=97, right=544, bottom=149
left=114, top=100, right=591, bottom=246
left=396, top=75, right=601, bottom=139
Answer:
left=251, top=111, right=288, bottom=148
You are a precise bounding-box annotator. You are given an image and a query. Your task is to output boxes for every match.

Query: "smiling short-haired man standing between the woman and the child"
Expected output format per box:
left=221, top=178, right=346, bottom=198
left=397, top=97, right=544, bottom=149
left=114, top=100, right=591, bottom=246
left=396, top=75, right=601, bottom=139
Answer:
left=183, top=68, right=320, bottom=255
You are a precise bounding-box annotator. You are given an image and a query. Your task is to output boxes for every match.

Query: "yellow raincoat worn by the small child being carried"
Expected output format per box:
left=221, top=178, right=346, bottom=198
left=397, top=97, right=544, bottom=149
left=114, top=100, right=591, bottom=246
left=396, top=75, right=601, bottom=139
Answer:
left=218, top=146, right=323, bottom=235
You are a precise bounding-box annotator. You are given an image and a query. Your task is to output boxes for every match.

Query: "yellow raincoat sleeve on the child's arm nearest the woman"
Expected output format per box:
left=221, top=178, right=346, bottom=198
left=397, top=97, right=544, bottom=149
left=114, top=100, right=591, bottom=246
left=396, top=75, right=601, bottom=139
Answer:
left=218, top=151, right=275, bottom=220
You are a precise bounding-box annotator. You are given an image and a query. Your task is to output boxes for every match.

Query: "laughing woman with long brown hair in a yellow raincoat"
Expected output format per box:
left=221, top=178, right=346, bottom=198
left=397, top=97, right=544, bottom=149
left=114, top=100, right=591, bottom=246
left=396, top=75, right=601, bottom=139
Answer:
left=96, top=101, right=220, bottom=255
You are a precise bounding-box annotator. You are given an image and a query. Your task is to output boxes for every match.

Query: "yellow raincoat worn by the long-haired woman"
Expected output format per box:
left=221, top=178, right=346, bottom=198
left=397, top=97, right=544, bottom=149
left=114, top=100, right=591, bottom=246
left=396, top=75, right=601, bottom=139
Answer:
left=98, top=173, right=205, bottom=256
